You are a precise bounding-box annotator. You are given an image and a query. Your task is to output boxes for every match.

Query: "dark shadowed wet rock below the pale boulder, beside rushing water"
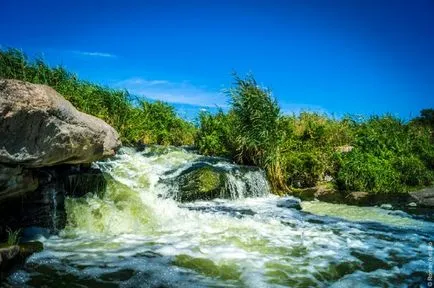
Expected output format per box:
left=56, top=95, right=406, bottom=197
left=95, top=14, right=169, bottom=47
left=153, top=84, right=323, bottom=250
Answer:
left=0, top=165, right=106, bottom=240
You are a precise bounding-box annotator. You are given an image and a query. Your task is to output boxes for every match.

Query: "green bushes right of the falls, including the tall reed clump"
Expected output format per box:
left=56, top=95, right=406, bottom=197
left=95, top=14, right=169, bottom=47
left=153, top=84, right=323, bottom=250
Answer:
left=196, top=75, right=434, bottom=193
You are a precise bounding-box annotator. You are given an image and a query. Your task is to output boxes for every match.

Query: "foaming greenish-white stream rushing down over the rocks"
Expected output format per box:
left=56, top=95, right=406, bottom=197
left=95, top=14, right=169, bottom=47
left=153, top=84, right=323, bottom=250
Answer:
left=0, top=148, right=434, bottom=287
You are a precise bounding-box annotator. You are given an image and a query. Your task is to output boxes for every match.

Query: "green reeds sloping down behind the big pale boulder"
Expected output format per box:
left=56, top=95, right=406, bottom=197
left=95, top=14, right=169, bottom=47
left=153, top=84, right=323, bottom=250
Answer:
left=0, top=49, right=195, bottom=145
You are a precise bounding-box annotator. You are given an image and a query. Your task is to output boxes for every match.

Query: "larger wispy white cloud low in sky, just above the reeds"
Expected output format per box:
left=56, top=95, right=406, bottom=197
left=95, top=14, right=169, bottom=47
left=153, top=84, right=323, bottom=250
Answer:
left=114, top=78, right=227, bottom=107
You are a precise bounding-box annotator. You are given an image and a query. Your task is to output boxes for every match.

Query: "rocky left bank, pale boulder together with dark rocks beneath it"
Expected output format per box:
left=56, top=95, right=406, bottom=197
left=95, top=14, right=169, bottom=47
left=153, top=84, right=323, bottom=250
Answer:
left=0, top=79, right=121, bottom=272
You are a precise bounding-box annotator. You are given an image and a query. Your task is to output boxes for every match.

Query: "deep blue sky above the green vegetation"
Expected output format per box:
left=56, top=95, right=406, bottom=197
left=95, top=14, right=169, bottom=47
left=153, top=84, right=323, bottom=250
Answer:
left=0, top=0, right=434, bottom=119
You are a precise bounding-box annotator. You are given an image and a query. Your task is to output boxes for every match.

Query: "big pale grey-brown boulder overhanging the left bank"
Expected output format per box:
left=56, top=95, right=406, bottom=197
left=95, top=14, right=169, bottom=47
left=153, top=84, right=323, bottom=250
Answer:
left=0, top=79, right=121, bottom=168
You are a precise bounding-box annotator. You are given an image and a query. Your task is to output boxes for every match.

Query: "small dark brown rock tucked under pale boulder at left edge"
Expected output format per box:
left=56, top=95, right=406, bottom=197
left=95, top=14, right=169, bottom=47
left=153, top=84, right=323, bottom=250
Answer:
left=0, top=164, right=39, bottom=201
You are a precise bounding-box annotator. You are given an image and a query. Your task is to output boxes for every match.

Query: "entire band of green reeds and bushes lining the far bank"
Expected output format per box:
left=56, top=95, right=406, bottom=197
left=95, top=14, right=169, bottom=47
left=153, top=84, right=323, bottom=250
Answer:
left=0, top=49, right=434, bottom=194
